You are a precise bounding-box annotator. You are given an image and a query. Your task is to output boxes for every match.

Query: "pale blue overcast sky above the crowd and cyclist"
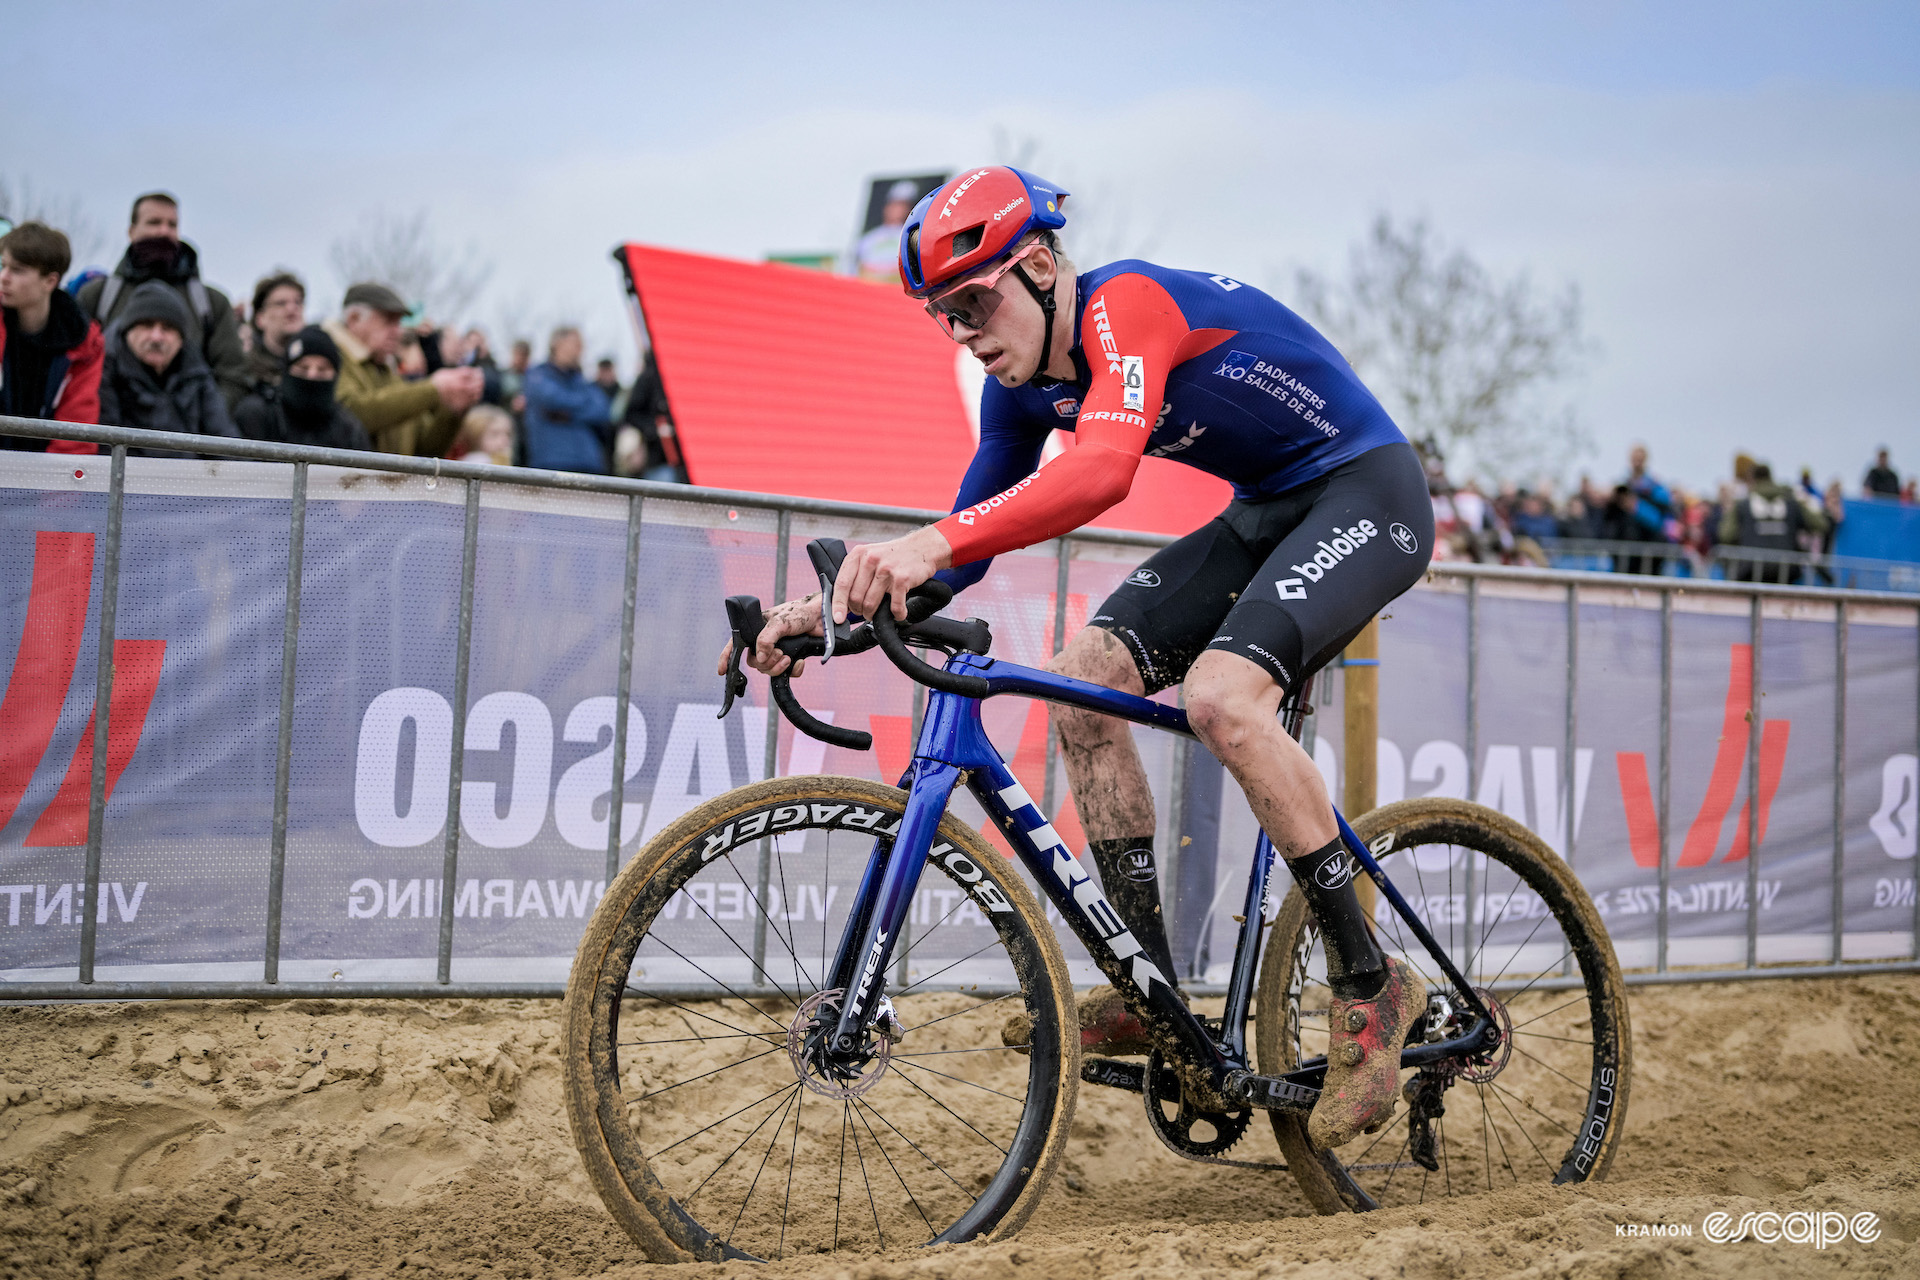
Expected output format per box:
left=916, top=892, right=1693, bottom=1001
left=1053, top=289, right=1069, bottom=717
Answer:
left=0, top=0, right=1920, bottom=489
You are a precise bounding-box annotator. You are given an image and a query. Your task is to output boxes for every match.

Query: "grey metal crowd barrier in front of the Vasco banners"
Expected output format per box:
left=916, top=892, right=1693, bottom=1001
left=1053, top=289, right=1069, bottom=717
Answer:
left=0, top=416, right=1920, bottom=1000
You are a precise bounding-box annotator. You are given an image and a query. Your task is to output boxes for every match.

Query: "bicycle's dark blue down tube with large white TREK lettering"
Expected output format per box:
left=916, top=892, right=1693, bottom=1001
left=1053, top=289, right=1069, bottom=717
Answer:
left=968, top=750, right=1225, bottom=1071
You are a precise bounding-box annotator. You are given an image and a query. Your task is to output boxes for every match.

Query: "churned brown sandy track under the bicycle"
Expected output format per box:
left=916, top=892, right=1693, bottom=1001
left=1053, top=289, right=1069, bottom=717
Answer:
left=0, top=977, right=1920, bottom=1280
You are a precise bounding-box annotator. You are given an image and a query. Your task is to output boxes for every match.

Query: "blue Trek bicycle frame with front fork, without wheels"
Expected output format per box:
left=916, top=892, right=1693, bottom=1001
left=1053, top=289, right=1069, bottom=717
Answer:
left=826, top=654, right=1492, bottom=1092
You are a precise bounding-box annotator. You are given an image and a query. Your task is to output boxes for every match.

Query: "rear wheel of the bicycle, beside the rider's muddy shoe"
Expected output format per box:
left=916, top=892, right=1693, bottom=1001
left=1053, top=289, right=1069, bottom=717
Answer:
left=1256, top=798, right=1632, bottom=1213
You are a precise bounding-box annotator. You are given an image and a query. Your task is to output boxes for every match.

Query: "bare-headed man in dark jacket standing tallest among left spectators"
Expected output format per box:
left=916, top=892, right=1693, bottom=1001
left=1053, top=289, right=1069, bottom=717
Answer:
left=77, top=192, right=248, bottom=409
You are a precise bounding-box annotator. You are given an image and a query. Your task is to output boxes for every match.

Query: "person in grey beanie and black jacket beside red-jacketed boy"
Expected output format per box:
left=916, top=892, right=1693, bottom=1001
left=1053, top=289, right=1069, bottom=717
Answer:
left=100, top=280, right=240, bottom=459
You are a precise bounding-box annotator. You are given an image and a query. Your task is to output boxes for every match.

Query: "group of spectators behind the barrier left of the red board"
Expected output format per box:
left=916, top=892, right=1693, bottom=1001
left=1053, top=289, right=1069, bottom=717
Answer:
left=0, top=192, right=687, bottom=482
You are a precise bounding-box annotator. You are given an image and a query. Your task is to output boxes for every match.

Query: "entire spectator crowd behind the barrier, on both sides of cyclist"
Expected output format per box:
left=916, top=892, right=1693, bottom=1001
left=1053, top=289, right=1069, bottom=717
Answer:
left=0, top=184, right=1916, bottom=581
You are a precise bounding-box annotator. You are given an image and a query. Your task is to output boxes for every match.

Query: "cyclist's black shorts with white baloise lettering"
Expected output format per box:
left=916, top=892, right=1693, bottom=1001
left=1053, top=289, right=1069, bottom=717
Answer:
left=1087, top=443, right=1434, bottom=693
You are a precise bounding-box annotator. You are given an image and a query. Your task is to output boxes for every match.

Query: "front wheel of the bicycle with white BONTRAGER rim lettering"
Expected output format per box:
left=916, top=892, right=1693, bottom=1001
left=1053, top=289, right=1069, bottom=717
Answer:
left=564, top=777, right=1079, bottom=1263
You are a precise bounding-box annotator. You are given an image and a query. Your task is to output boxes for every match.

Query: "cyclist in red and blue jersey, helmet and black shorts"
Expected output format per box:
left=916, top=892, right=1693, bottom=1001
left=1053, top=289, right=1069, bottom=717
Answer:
left=725, top=165, right=1432, bottom=1150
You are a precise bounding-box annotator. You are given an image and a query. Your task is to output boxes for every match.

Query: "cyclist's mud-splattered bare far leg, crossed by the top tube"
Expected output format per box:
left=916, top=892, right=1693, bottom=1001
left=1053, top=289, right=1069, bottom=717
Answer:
left=1046, top=628, right=1152, bottom=841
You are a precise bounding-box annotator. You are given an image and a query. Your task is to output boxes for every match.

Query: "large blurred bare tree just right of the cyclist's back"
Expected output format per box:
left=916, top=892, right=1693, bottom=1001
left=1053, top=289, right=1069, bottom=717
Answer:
left=1294, top=213, right=1596, bottom=480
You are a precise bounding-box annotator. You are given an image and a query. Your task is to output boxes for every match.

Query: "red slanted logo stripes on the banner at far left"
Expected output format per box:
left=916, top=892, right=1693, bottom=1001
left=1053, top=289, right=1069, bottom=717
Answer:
left=0, top=532, right=167, bottom=848
